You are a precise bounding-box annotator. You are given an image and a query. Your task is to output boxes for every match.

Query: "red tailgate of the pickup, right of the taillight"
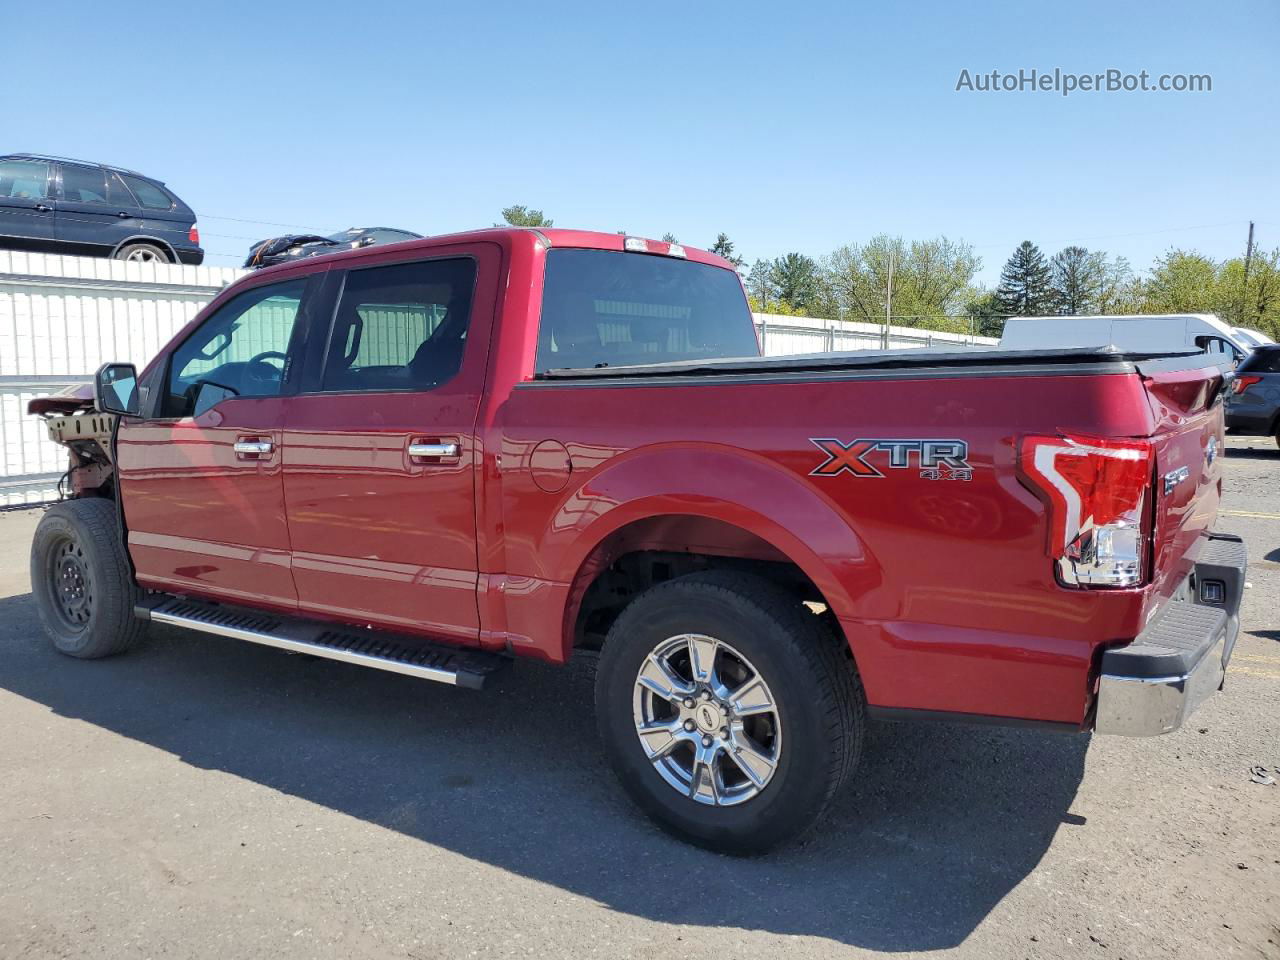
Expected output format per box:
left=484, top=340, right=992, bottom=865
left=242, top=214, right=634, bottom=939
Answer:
left=1138, top=356, right=1230, bottom=609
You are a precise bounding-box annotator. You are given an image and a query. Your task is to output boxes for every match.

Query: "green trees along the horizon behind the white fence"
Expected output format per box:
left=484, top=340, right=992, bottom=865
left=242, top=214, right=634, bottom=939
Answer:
left=503, top=206, right=1280, bottom=340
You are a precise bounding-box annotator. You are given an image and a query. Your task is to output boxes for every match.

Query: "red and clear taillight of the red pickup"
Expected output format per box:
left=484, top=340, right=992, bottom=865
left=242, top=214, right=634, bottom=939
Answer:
left=1020, top=435, right=1155, bottom=588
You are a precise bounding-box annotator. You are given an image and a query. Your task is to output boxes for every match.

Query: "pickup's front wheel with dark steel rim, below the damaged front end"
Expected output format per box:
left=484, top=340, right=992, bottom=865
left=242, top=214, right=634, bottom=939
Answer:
left=31, top=498, right=146, bottom=659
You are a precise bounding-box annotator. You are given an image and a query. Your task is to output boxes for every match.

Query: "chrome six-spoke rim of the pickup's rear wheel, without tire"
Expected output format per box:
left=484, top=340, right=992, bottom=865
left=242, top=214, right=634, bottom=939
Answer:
left=634, top=634, right=782, bottom=806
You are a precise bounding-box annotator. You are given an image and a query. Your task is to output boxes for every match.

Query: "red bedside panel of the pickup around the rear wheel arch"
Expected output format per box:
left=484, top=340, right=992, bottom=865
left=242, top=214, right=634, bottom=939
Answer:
left=500, top=372, right=1172, bottom=723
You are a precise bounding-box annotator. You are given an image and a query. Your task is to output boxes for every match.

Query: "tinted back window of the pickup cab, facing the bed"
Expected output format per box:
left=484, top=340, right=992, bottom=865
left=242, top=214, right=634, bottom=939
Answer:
left=538, top=250, right=760, bottom=370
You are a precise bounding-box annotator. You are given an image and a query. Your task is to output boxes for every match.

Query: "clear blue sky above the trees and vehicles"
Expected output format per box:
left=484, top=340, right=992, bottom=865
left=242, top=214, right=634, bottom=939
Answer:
left=10, top=0, right=1280, bottom=284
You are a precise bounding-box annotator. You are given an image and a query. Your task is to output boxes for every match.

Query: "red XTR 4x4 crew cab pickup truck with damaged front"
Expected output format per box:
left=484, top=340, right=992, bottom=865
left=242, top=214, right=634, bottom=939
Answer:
left=31, top=229, right=1244, bottom=852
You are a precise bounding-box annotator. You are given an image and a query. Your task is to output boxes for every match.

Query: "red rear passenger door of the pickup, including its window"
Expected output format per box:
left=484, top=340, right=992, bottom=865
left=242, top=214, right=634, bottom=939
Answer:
left=284, top=244, right=498, bottom=644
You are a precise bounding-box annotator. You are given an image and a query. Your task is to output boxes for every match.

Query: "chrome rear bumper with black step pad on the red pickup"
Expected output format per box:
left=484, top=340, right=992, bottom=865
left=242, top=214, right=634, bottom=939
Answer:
left=1094, top=532, right=1247, bottom=736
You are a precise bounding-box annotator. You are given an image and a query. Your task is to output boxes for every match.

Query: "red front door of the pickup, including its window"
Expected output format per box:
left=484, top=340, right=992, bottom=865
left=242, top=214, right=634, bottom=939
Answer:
left=116, top=275, right=323, bottom=611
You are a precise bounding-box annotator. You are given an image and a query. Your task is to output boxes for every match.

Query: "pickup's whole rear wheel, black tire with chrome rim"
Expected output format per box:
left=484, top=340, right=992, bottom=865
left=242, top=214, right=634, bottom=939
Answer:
left=595, top=571, right=865, bottom=854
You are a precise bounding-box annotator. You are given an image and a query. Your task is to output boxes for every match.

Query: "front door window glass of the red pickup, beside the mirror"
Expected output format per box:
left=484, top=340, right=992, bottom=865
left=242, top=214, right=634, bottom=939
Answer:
left=164, top=279, right=306, bottom=417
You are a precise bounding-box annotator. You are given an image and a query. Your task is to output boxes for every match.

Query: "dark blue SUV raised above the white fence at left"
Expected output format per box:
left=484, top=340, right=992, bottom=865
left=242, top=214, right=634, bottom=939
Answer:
left=0, top=154, right=205, bottom=264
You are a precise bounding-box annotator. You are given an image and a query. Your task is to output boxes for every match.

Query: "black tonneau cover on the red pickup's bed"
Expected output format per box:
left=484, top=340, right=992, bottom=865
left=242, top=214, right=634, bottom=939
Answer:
left=535, top=347, right=1213, bottom=380
